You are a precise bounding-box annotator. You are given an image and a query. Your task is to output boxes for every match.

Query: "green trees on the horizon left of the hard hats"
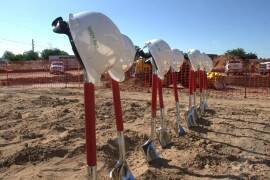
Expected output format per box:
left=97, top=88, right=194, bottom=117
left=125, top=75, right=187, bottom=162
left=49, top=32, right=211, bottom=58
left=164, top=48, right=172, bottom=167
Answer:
left=2, top=48, right=69, bottom=61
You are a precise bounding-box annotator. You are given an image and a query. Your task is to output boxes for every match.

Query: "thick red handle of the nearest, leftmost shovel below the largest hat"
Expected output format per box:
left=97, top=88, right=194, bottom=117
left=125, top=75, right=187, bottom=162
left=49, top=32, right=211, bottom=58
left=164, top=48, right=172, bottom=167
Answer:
left=84, top=83, right=97, bottom=166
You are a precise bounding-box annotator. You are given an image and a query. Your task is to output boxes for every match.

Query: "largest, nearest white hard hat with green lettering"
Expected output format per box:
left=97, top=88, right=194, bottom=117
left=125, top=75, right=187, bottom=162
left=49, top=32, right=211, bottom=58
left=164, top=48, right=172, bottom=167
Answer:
left=69, top=12, right=123, bottom=84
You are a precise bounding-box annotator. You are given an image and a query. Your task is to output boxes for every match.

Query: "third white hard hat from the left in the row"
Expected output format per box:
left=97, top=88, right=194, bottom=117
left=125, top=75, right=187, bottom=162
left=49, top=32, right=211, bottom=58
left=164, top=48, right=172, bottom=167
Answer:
left=146, top=39, right=173, bottom=79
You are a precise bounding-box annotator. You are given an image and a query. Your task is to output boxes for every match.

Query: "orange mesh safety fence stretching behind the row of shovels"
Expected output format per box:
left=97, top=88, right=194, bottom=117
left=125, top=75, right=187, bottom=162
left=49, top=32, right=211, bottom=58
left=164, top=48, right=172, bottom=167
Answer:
left=0, top=60, right=270, bottom=98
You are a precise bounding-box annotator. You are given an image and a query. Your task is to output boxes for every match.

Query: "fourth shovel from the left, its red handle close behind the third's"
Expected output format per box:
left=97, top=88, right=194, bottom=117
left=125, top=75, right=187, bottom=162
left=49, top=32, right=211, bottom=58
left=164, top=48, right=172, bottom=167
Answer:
left=157, top=78, right=170, bottom=148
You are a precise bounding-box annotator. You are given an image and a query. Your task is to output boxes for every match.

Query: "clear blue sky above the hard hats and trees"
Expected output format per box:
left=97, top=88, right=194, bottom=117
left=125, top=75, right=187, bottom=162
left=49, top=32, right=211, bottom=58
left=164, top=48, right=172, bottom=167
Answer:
left=0, top=0, right=270, bottom=58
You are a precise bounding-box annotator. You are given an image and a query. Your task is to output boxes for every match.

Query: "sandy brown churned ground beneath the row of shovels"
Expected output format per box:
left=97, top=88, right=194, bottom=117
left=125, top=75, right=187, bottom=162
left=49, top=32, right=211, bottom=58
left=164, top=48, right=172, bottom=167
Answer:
left=0, top=84, right=270, bottom=180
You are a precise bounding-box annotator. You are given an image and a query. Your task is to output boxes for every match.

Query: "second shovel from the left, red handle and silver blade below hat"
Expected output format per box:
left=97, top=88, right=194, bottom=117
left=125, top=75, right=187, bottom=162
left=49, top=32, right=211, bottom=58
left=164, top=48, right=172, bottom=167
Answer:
left=110, top=79, right=135, bottom=180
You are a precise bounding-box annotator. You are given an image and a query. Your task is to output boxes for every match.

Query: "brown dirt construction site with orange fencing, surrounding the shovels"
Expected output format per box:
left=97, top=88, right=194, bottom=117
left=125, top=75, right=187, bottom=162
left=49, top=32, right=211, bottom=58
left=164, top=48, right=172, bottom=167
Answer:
left=0, top=52, right=270, bottom=179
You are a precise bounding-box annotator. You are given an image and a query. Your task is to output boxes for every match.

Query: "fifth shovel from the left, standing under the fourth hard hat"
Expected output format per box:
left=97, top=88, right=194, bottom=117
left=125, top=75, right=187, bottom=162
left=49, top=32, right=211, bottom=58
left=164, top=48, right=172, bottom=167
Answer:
left=172, top=71, right=185, bottom=136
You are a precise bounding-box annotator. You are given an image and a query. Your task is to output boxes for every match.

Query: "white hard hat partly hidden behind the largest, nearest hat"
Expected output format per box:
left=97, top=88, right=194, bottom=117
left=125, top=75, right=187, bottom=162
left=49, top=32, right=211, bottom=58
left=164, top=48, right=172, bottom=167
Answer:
left=108, top=34, right=136, bottom=82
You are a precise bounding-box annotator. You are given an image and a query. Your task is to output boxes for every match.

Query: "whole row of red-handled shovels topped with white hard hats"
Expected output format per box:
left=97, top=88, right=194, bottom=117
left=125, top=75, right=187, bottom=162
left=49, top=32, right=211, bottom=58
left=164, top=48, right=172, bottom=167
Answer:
left=52, top=12, right=212, bottom=180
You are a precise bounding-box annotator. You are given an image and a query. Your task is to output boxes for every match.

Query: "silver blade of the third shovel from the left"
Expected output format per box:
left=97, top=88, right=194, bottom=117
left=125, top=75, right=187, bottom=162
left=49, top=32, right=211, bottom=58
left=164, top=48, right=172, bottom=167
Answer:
left=142, top=139, right=160, bottom=163
